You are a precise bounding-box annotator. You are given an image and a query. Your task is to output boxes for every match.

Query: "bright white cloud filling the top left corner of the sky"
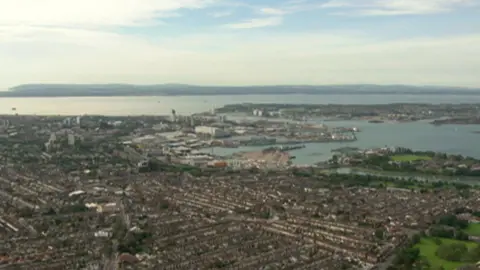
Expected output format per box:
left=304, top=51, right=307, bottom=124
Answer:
left=0, top=0, right=216, bottom=27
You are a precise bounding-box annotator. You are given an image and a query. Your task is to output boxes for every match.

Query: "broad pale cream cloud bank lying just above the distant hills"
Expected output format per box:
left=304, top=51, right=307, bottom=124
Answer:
left=0, top=23, right=480, bottom=89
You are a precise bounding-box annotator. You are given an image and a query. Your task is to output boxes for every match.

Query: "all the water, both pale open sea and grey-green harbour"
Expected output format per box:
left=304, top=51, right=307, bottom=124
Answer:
left=0, top=94, right=480, bottom=164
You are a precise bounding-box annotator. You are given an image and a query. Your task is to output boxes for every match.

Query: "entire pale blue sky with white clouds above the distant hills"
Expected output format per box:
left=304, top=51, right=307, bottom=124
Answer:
left=0, top=0, right=480, bottom=89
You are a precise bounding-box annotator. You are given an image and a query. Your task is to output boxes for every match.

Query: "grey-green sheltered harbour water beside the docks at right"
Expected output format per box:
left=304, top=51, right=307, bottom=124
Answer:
left=209, top=121, right=480, bottom=164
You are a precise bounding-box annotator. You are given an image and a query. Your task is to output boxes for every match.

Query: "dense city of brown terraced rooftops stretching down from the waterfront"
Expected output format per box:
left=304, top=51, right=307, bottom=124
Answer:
left=0, top=104, right=480, bottom=270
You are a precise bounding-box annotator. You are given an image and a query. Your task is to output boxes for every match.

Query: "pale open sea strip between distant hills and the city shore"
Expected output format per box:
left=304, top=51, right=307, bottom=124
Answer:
left=0, top=95, right=480, bottom=115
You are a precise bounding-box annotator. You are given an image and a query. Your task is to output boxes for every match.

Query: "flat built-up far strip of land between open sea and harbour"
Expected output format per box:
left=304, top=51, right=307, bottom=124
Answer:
left=216, top=103, right=480, bottom=124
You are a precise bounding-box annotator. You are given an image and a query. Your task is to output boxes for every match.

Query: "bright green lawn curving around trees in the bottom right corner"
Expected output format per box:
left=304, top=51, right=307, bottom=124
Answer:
left=415, top=237, right=475, bottom=270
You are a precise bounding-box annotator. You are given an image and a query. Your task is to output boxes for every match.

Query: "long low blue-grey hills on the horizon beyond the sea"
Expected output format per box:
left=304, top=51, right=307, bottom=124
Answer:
left=0, top=84, right=480, bottom=97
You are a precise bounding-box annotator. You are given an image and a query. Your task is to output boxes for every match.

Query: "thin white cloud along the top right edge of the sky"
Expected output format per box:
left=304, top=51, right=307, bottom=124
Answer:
left=322, top=0, right=479, bottom=16
